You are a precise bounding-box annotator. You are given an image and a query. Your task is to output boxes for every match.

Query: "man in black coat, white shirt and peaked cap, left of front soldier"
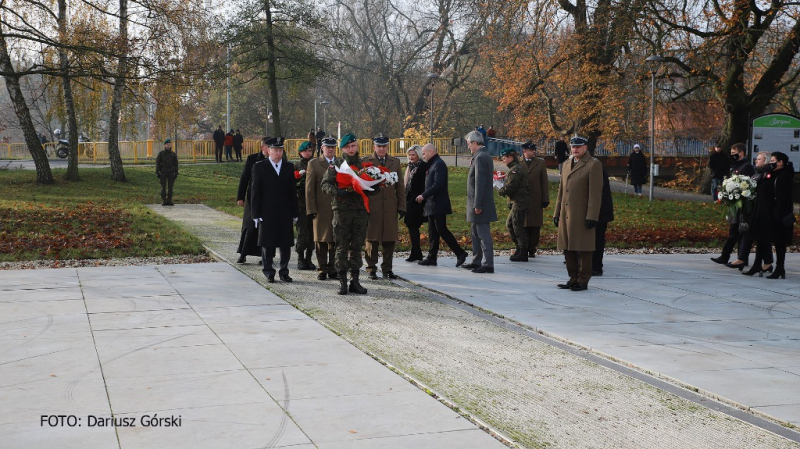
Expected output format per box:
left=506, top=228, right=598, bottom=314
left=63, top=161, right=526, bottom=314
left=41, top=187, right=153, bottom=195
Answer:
left=251, top=137, right=299, bottom=282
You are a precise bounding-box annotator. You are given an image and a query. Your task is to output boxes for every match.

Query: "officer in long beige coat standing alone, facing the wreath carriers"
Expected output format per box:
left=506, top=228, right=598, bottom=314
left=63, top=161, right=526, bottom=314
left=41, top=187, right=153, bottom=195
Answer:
left=553, top=136, right=603, bottom=291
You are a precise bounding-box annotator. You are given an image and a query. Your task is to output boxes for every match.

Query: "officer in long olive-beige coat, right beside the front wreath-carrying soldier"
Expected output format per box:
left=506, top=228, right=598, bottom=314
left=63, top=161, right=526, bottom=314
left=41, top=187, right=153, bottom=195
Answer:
left=363, top=134, right=406, bottom=279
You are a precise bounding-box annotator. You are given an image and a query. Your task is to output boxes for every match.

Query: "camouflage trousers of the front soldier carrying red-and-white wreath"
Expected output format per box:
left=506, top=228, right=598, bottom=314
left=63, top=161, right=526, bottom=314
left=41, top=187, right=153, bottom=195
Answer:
left=333, top=210, right=369, bottom=271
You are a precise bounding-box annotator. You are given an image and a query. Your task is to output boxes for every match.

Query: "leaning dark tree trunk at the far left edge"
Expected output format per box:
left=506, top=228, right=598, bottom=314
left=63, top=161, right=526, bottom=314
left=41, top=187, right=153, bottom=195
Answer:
left=0, top=29, right=53, bottom=184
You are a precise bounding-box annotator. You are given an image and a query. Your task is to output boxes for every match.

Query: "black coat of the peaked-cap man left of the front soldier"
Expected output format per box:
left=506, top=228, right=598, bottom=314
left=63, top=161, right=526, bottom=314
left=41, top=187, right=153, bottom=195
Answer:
left=250, top=159, right=300, bottom=248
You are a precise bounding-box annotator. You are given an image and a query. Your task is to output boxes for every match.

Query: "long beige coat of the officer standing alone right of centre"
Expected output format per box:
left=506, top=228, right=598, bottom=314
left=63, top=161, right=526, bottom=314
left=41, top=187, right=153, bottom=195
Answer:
left=553, top=152, right=603, bottom=251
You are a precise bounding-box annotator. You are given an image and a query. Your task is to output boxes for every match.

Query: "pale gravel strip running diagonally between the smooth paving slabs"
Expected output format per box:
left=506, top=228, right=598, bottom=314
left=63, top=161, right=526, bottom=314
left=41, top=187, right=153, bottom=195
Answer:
left=145, top=205, right=800, bottom=449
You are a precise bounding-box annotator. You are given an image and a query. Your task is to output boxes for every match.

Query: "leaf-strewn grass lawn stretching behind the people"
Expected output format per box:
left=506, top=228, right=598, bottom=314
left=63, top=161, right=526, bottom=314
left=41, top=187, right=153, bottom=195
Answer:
left=0, top=163, right=752, bottom=261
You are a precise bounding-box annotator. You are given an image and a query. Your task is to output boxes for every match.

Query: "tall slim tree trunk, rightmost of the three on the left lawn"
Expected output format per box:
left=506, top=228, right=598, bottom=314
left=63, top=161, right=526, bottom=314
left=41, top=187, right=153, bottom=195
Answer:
left=108, top=0, right=128, bottom=182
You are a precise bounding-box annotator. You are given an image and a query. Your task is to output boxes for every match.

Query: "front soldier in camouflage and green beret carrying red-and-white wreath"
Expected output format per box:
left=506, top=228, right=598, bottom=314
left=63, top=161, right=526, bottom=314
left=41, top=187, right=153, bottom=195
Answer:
left=322, top=134, right=378, bottom=295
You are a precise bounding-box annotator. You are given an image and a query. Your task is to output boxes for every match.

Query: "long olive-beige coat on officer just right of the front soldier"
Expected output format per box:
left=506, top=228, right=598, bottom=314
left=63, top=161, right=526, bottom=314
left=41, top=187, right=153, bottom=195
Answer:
left=361, top=153, right=406, bottom=242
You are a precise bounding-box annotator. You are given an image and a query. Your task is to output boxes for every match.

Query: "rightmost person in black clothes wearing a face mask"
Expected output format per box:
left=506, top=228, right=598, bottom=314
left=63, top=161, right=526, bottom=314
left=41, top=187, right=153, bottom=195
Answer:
left=751, top=151, right=796, bottom=279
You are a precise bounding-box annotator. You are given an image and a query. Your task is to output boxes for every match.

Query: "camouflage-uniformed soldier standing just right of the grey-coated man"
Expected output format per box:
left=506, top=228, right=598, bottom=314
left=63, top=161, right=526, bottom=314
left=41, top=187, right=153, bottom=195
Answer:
left=497, top=148, right=531, bottom=262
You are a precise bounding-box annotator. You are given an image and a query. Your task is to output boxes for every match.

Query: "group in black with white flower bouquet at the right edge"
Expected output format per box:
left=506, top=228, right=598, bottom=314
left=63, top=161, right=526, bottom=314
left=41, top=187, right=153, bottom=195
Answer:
left=709, top=143, right=795, bottom=279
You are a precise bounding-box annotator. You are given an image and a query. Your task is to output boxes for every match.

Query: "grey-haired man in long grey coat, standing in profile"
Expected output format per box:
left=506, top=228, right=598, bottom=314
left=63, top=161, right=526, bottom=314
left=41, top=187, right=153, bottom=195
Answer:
left=462, top=131, right=497, bottom=273
